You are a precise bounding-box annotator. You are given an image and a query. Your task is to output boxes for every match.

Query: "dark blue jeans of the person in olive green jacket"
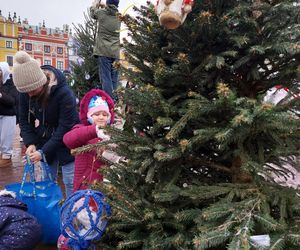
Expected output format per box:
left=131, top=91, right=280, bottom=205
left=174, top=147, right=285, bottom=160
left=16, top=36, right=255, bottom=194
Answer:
left=98, top=56, right=119, bottom=100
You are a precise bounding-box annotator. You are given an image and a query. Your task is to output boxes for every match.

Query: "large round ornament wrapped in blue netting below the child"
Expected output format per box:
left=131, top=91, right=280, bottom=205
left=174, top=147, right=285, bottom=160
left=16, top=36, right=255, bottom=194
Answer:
left=58, top=189, right=111, bottom=250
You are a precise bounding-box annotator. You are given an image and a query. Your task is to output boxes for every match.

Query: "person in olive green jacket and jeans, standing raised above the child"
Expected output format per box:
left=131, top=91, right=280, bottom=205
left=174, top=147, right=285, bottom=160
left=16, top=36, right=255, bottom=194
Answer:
left=90, top=0, right=121, bottom=101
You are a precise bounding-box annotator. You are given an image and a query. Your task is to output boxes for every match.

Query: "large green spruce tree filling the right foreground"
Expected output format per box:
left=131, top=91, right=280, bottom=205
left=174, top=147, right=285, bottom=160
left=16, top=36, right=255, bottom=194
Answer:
left=74, top=0, right=300, bottom=250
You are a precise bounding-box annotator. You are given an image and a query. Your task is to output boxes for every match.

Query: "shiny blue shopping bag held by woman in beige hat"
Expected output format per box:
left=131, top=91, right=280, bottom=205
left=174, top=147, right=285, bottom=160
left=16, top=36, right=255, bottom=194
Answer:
left=5, top=156, right=63, bottom=244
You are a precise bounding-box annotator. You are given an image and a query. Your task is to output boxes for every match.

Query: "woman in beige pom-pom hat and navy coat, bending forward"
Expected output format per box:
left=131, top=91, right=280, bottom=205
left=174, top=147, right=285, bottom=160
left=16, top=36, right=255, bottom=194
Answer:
left=13, top=51, right=79, bottom=197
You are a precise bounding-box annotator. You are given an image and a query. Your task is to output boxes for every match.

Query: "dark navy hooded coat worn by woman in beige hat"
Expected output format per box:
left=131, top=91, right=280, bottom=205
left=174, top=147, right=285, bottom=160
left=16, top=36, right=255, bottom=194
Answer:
left=19, top=66, right=79, bottom=165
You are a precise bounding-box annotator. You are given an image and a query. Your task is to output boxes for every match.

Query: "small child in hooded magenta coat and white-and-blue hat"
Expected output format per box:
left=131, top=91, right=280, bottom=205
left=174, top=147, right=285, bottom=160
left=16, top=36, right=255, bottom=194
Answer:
left=63, top=89, right=119, bottom=192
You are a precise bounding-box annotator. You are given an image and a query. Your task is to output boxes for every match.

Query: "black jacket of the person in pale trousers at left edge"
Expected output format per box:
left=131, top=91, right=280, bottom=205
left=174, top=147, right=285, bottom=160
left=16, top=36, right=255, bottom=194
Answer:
left=0, top=79, right=19, bottom=116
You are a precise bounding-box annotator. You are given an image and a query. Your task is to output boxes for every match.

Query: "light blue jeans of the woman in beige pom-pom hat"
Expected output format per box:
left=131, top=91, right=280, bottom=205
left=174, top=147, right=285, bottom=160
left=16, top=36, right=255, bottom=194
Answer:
left=44, top=160, right=75, bottom=198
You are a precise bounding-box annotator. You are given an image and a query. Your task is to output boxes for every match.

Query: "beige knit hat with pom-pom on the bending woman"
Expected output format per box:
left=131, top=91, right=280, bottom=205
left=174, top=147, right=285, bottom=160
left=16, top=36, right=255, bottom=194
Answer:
left=13, top=51, right=47, bottom=93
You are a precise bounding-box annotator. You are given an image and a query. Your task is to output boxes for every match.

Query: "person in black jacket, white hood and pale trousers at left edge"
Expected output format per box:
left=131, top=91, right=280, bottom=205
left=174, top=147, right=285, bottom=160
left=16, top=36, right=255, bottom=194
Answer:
left=0, top=62, right=18, bottom=166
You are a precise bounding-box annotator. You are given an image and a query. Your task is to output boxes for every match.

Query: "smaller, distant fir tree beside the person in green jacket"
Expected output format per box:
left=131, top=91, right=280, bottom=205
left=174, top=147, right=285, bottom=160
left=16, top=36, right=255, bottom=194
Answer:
left=71, top=11, right=101, bottom=98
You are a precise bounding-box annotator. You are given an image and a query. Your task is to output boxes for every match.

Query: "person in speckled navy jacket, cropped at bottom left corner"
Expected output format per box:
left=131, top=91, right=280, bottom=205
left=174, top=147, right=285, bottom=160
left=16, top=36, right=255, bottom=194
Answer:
left=0, top=190, right=41, bottom=250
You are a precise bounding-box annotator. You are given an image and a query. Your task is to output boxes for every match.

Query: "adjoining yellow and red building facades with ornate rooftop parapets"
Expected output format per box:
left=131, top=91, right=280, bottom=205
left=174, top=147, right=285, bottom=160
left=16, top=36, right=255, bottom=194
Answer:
left=0, top=10, right=69, bottom=71
